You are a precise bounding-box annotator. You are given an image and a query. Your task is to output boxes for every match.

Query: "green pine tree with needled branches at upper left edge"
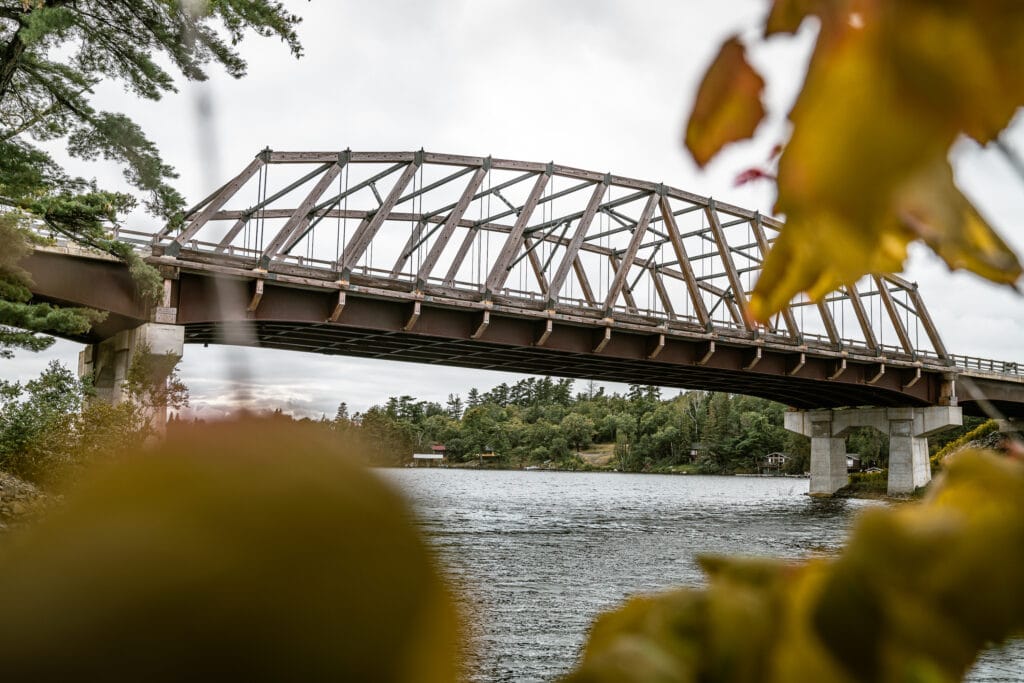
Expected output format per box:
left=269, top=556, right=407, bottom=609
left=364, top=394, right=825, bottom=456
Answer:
left=0, top=0, right=302, bottom=353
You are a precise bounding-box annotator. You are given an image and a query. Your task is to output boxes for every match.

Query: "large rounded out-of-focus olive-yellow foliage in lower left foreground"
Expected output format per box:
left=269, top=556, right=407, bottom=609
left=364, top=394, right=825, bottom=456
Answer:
left=0, top=420, right=460, bottom=683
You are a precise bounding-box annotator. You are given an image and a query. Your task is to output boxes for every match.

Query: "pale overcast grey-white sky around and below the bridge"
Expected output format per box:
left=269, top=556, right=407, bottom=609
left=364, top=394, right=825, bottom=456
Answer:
left=0, top=0, right=1024, bottom=417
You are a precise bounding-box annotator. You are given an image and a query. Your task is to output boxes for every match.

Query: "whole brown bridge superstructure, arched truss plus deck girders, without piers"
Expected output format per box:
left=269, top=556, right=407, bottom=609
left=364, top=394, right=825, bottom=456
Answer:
left=18, top=150, right=991, bottom=413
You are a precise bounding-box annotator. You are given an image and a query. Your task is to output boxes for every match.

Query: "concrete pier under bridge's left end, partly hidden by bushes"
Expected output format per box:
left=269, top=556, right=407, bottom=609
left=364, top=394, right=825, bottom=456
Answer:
left=78, top=323, right=185, bottom=433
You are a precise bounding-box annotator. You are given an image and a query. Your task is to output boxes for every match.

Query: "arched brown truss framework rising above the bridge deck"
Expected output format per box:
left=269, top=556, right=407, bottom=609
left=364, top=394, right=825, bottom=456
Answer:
left=156, top=150, right=948, bottom=361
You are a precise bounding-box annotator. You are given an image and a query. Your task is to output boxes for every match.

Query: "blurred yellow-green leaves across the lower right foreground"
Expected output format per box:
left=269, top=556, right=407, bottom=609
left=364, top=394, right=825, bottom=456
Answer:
left=564, top=452, right=1024, bottom=683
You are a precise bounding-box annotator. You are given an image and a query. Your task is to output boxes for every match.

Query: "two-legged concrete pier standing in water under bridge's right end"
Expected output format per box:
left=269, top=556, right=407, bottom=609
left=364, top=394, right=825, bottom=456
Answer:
left=785, top=405, right=964, bottom=496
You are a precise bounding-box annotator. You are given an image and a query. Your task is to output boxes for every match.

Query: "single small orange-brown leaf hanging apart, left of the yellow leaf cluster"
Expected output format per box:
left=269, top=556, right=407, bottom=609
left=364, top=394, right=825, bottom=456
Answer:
left=685, top=36, right=765, bottom=166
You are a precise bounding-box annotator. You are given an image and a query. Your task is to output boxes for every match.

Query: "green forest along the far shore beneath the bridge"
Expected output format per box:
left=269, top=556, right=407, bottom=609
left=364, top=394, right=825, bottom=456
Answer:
left=292, top=377, right=977, bottom=474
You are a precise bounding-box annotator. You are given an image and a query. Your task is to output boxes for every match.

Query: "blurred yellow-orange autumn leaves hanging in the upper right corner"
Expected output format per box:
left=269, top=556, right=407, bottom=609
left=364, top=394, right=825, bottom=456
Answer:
left=686, top=0, right=1024, bottom=321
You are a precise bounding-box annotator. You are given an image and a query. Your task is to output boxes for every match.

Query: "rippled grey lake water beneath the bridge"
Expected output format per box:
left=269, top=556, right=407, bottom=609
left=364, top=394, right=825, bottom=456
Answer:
left=384, top=469, right=1024, bottom=683
